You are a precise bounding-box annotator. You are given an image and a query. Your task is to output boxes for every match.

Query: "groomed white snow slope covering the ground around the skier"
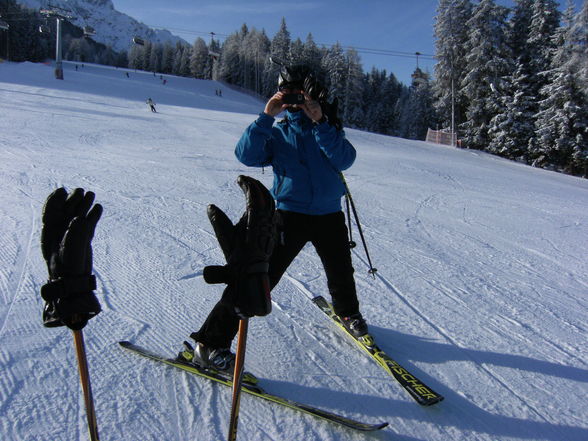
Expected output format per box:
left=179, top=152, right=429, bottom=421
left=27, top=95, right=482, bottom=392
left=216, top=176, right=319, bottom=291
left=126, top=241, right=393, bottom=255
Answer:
left=0, top=63, right=588, bottom=441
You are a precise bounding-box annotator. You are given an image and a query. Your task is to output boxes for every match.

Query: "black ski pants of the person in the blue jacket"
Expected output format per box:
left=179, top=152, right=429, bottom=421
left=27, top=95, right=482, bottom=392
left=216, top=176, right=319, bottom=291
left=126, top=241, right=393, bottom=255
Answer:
left=192, top=210, right=359, bottom=348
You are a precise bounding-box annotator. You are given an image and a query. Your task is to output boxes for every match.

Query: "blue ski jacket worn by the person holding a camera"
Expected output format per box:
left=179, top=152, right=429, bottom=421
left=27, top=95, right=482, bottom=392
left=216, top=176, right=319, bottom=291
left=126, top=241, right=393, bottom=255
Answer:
left=235, top=111, right=356, bottom=215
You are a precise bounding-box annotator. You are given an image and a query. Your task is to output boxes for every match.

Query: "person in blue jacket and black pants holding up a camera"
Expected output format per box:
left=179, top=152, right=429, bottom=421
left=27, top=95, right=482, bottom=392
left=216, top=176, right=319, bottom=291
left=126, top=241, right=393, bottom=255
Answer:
left=181, top=66, right=368, bottom=374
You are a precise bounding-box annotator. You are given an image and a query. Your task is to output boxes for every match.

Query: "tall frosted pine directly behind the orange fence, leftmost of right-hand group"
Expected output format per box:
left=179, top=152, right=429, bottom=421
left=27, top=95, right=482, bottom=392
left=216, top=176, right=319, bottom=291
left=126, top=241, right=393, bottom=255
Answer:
left=433, top=0, right=472, bottom=138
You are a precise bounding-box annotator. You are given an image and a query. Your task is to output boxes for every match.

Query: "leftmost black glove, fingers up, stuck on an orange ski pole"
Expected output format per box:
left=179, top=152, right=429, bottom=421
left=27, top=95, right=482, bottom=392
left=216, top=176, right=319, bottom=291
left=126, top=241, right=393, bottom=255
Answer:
left=41, top=188, right=102, bottom=330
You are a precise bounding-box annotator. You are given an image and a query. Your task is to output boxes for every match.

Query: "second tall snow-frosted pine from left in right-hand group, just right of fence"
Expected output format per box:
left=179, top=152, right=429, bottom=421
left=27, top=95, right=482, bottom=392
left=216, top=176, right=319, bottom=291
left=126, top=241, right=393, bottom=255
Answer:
left=459, top=0, right=511, bottom=150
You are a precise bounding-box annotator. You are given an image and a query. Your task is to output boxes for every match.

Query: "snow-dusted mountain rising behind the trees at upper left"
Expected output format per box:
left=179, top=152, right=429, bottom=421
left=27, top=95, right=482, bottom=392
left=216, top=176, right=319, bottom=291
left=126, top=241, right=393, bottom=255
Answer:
left=18, top=0, right=186, bottom=52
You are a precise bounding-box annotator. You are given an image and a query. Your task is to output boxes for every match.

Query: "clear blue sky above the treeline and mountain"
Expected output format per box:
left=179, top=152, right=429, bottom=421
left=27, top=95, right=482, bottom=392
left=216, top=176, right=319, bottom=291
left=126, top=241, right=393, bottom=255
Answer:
left=113, top=0, right=582, bottom=84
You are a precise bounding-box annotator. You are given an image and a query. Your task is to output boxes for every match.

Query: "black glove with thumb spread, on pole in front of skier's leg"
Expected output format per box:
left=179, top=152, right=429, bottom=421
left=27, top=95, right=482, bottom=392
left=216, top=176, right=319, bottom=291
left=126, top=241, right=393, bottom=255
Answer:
left=204, top=176, right=275, bottom=318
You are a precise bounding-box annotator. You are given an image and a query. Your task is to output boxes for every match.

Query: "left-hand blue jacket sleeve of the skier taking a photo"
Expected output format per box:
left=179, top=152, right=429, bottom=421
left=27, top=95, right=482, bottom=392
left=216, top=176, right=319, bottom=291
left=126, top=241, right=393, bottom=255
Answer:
left=235, top=113, right=275, bottom=167
